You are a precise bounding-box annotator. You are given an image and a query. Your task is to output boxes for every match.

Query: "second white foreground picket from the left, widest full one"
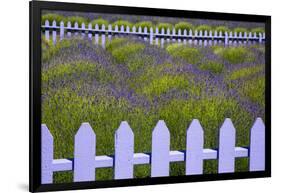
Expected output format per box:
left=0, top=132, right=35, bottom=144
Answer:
left=73, top=123, right=96, bottom=182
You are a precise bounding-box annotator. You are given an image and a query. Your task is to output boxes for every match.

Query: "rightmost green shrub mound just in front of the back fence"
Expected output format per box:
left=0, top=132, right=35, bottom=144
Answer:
left=214, top=47, right=255, bottom=64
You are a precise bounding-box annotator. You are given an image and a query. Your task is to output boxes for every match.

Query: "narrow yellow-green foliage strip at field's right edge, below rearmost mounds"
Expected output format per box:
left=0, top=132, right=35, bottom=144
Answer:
left=229, top=66, right=264, bottom=80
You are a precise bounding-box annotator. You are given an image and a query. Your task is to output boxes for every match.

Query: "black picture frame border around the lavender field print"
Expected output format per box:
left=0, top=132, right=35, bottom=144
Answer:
left=29, top=1, right=271, bottom=192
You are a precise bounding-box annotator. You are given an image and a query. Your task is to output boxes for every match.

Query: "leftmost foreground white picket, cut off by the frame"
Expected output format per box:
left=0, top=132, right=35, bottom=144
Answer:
left=41, top=124, right=54, bottom=184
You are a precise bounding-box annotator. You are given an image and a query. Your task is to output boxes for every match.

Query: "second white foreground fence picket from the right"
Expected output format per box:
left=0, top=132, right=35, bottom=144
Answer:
left=218, top=118, right=236, bottom=173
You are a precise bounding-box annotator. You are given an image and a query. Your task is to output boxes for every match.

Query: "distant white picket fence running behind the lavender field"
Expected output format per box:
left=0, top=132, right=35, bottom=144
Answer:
left=42, top=20, right=265, bottom=47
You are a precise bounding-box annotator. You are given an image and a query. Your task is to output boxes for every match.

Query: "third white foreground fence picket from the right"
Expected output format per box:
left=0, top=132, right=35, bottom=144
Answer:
left=185, top=119, right=204, bottom=175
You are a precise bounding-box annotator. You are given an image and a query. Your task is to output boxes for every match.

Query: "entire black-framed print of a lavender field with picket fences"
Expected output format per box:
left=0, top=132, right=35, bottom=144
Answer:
left=30, top=1, right=271, bottom=192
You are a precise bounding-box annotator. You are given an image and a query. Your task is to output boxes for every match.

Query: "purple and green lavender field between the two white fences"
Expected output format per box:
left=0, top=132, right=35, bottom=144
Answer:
left=42, top=32, right=265, bottom=183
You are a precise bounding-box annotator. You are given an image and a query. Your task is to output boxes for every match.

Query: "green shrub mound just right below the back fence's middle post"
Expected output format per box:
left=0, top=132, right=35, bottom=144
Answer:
left=166, top=44, right=201, bottom=64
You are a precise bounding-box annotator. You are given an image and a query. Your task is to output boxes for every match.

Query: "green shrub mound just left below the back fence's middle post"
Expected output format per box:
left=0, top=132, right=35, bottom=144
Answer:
left=112, top=43, right=145, bottom=63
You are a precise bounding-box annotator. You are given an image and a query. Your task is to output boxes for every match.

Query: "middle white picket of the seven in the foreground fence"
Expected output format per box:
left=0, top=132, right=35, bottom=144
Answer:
left=151, top=120, right=170, bottom=177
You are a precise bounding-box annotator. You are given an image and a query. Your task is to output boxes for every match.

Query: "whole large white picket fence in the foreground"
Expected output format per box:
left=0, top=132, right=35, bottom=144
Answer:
left=41, top=118, right=265, bottom=184
